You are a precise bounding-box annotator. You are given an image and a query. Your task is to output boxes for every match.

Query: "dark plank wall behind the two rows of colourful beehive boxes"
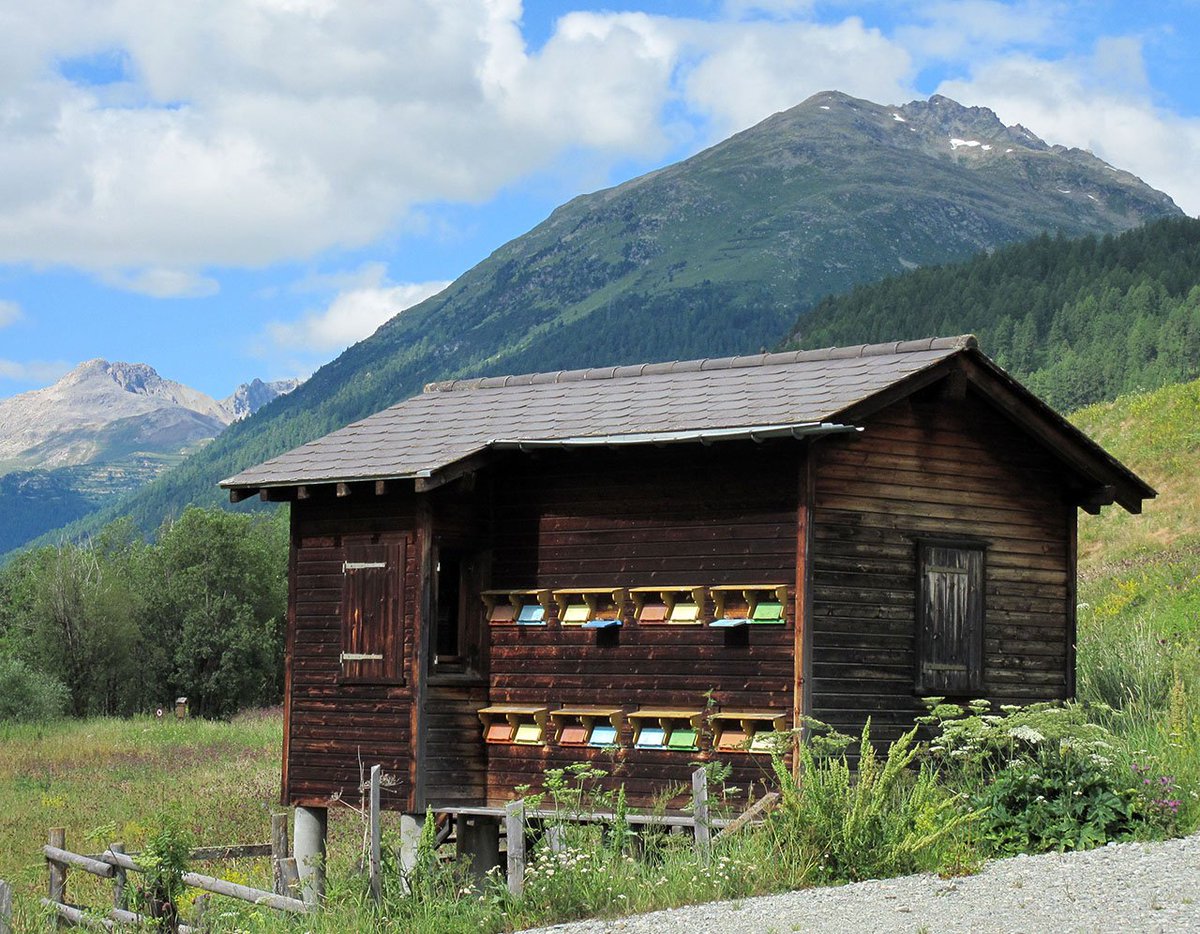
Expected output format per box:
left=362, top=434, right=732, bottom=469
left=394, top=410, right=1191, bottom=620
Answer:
left=475, top=442, right=800, bottom=806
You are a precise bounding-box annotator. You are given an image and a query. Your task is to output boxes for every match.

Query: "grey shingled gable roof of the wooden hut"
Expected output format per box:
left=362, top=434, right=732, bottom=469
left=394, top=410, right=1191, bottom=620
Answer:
left=221, top=335, right=1153, bottom=505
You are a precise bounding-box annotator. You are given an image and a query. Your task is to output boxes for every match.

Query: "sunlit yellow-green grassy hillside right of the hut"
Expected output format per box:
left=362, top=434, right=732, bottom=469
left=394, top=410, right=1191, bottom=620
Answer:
left=1072, top=381, right=1200, bottom=830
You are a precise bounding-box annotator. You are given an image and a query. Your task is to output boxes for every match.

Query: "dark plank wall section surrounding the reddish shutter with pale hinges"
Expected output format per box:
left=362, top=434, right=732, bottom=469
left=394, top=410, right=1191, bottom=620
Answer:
left=284, top=493, right=421, bottom=808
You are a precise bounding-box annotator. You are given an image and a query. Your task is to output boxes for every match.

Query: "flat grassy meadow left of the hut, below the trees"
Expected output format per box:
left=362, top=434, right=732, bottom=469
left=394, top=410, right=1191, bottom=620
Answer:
left=0, top=712, right=282, bottom=930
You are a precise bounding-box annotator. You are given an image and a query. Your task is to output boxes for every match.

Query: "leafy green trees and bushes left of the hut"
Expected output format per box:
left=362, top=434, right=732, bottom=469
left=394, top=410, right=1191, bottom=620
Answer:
left=0, top=507, right=288, bottom=719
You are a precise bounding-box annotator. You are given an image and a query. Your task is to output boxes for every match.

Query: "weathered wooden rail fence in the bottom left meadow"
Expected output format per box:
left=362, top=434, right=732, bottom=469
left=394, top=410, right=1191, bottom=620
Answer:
left=43, top=814, right=310, bottom=921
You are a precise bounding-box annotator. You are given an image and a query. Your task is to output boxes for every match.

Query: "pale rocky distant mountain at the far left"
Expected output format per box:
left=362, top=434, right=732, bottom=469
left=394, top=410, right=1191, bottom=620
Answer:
left=0, top=359, right=298, bottom=553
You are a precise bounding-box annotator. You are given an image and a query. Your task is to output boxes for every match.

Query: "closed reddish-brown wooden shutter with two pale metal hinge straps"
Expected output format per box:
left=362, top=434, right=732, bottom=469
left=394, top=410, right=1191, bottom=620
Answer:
left=340, top=541, right=406, bottom=682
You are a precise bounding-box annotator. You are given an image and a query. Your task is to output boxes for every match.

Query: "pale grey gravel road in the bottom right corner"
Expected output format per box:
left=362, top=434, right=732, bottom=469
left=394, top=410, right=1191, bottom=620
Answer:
left=523, top=834, right=1200, bottom=934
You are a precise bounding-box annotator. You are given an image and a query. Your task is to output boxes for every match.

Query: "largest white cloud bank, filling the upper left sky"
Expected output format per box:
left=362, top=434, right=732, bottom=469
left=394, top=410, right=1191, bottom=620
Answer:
left=0, top=0, right=674, bottom=276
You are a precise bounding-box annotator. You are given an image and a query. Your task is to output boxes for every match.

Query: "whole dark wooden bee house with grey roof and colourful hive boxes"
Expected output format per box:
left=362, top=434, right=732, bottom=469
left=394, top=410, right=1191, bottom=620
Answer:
left=224, top=339, right=1153, bottom=814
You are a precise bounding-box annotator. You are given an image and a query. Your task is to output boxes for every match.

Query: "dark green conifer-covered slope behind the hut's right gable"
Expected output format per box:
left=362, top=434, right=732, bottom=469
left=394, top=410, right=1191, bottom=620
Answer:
left=786, top=217, right=1200, bottom=411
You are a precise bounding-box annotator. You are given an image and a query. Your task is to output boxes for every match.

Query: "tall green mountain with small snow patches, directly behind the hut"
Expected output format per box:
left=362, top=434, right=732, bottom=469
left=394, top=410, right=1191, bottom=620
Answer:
left=9, top=91, right=1182, bottom=549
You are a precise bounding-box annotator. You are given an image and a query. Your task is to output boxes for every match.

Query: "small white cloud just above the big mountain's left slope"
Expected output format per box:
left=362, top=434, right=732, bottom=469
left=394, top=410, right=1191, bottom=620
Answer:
left=266, top=276, right=450, bottom=353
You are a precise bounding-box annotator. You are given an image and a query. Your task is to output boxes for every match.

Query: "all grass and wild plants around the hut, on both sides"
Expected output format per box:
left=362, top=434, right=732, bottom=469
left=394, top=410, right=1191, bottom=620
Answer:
left=0, top=382, right=1200, bottom=933
